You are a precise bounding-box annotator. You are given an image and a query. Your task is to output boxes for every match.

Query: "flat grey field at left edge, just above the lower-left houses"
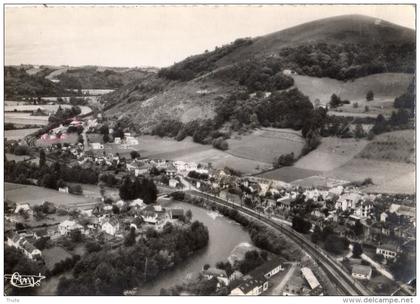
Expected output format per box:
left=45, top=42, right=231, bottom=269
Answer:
left=4, top=183, right=90, bottom=207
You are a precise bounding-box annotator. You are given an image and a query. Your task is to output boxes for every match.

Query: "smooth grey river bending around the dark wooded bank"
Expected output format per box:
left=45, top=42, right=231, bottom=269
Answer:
left=137, top=201, right=252, bottom=295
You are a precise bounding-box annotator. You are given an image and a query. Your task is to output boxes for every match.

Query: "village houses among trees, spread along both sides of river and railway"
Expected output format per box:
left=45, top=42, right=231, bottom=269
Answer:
left=5, top=111, right=415, bottom=295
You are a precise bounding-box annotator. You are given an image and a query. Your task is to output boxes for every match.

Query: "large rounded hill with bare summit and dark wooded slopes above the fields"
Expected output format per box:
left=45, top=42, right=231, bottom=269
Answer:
left=102, top=15, right=415, bottom=131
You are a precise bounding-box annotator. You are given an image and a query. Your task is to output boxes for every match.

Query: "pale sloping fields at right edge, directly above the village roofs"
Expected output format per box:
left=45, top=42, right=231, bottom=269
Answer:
left=260, top=130, right=415, bottom=194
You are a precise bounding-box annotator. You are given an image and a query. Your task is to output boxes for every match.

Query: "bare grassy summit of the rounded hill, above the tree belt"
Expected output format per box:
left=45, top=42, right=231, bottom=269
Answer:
left=217, top=15, right=415, bottom=66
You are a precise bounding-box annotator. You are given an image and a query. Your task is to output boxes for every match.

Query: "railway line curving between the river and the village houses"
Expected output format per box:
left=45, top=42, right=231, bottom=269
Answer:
left=186, top=185, right=371, bottom=296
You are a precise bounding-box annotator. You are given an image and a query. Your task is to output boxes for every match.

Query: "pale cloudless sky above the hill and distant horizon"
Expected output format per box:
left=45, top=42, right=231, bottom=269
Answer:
left=5, top=5, right=415, bottom=67
